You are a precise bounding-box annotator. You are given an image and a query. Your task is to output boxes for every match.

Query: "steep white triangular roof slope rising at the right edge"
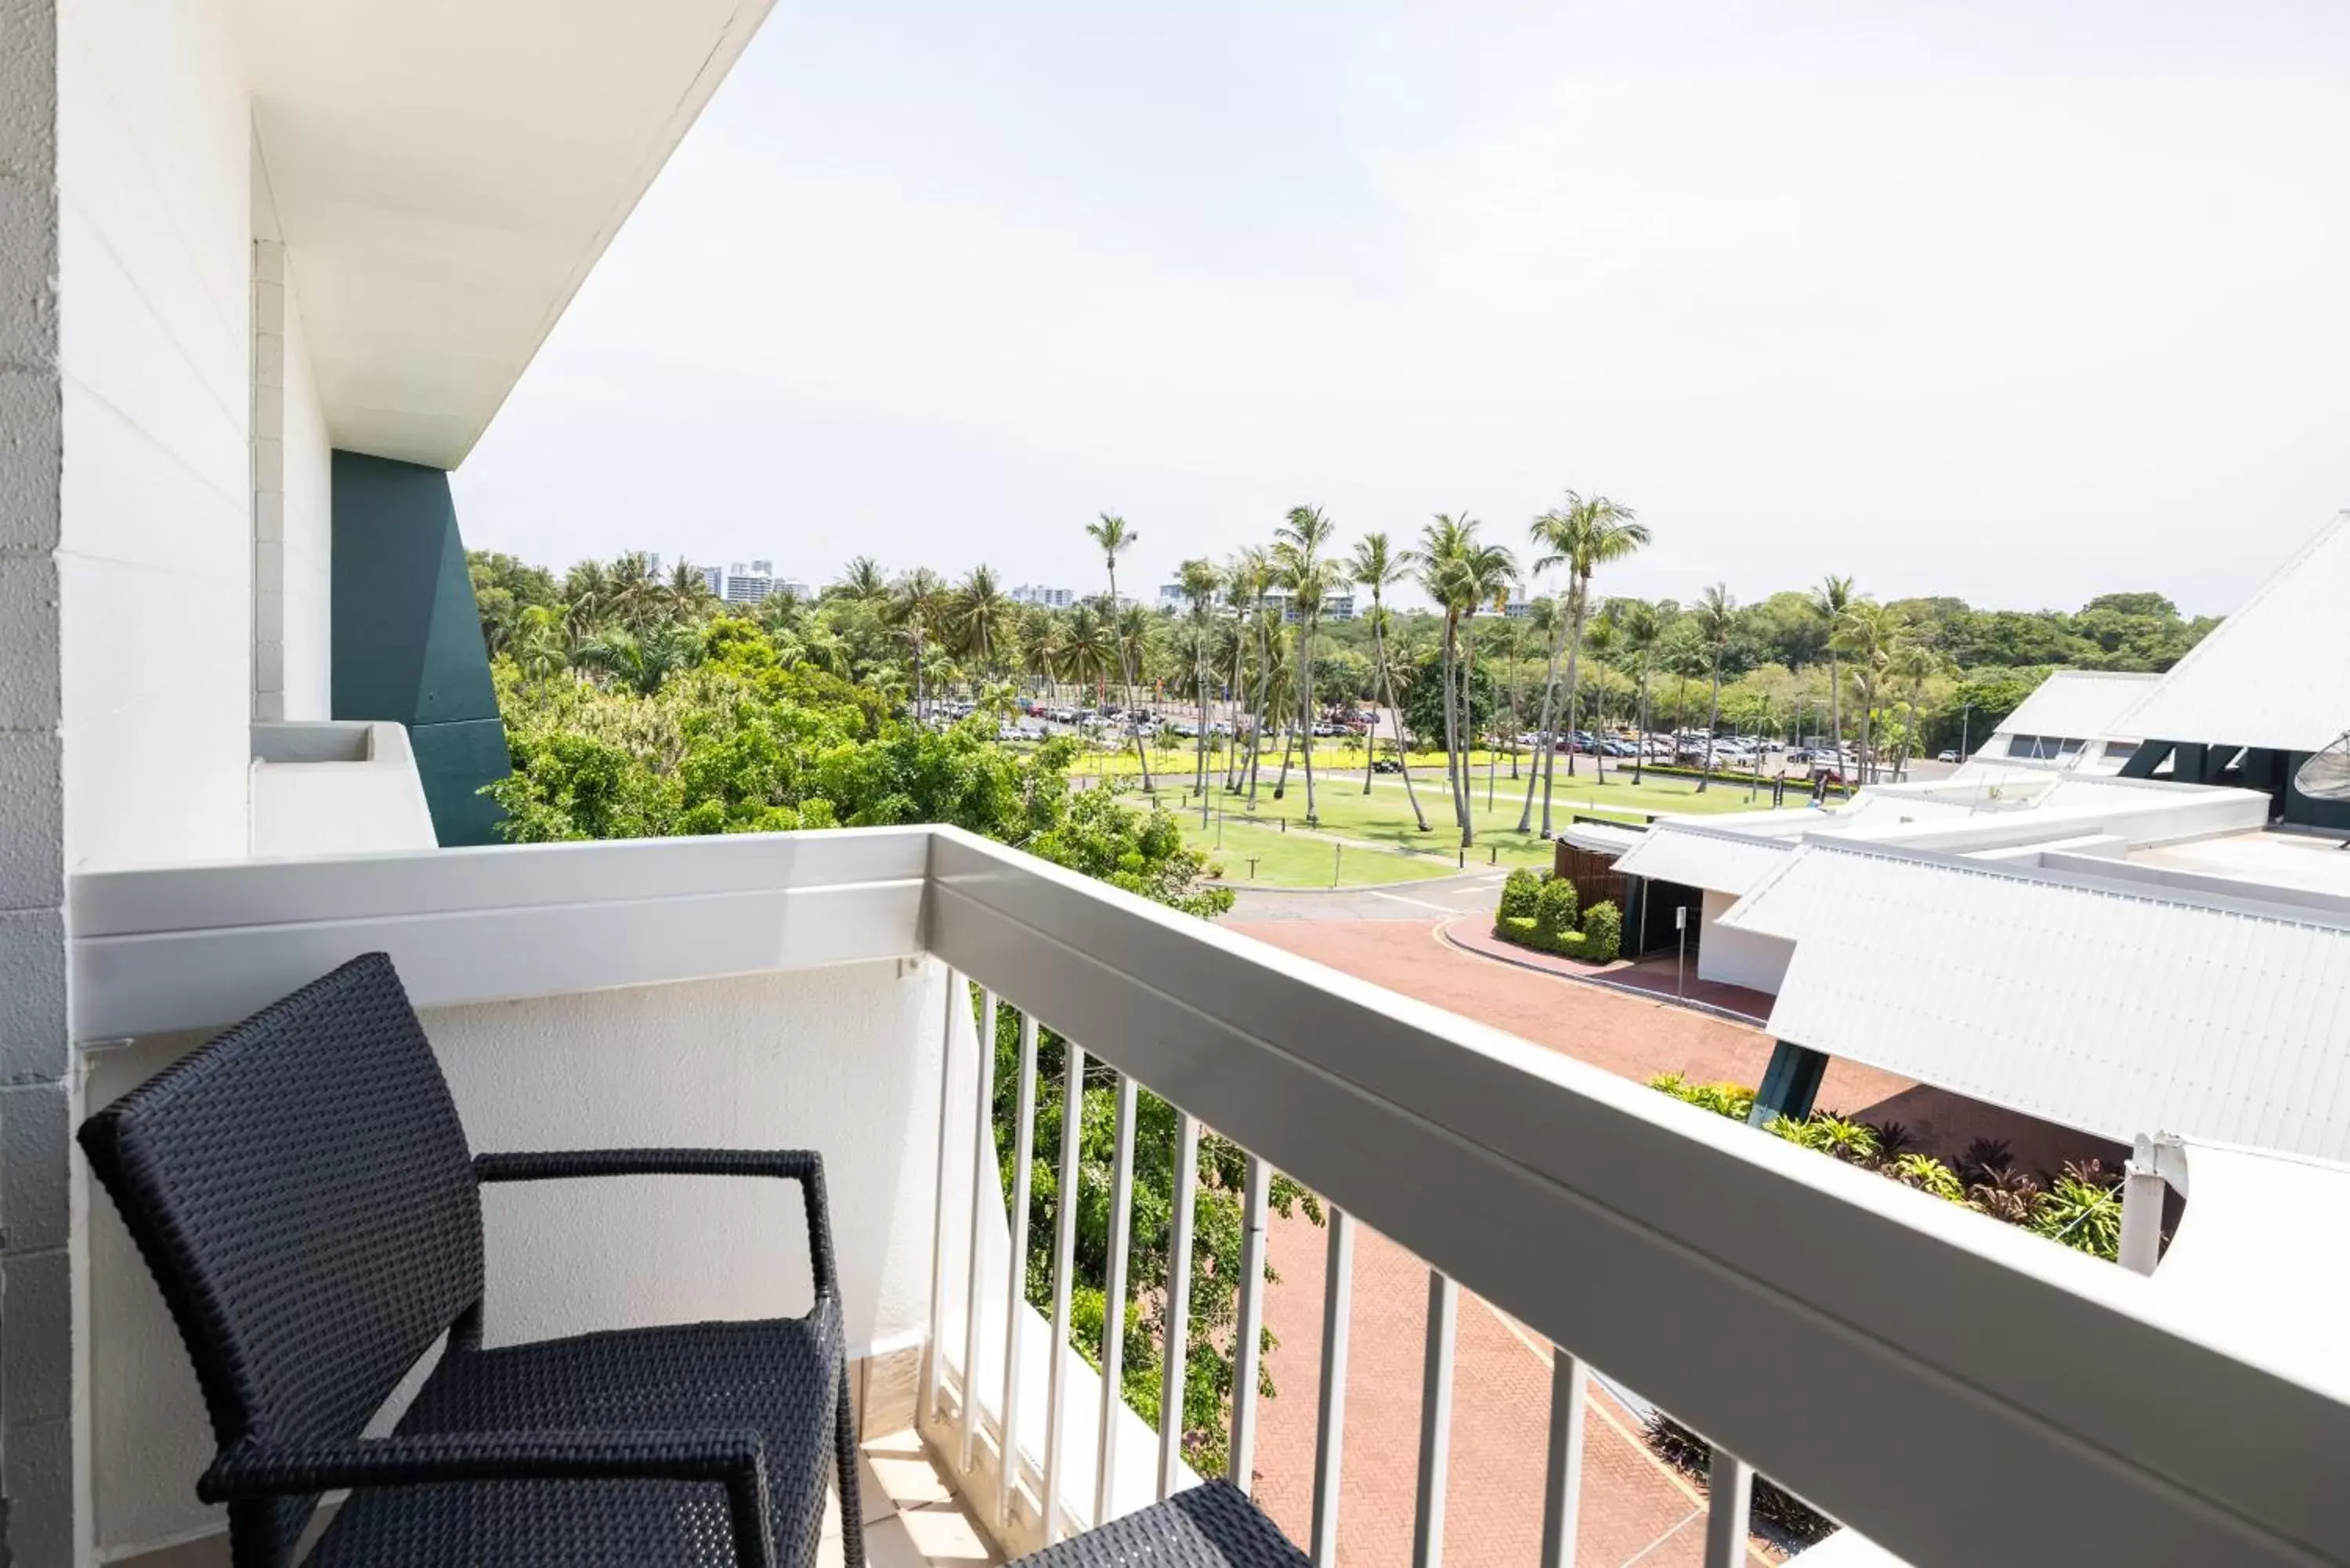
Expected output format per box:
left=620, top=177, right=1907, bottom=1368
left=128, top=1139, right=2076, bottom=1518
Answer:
left=2113, top=515, right=2350, bottom=752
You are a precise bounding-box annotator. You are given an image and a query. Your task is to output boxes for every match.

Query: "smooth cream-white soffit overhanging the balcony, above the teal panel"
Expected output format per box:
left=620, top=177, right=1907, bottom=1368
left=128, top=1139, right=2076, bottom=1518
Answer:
left=228, top=0, right=771, bottom=468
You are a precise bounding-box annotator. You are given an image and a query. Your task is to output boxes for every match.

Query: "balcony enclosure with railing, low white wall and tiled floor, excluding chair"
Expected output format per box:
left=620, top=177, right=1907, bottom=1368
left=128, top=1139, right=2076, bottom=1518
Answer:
left=70, top=828, right=2350, bottom=1568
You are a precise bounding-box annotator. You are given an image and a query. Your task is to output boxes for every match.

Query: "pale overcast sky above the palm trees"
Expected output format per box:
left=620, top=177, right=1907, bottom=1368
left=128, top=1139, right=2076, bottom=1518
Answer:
left=456, top=0, right=2350, bottom=611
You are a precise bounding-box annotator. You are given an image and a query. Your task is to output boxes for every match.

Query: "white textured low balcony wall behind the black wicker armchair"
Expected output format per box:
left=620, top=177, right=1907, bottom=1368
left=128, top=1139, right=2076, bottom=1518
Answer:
left=89, top=964, right=971, bottom=1552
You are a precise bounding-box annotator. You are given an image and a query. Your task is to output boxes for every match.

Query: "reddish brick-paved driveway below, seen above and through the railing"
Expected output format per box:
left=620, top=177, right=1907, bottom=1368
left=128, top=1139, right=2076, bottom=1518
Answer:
left=1231, top=917, right=2113, bottom=1568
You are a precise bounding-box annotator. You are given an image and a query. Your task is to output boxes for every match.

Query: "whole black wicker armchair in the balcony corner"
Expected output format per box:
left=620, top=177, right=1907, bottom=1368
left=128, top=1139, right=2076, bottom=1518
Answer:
left=80, top=952, right=865, bottom=1568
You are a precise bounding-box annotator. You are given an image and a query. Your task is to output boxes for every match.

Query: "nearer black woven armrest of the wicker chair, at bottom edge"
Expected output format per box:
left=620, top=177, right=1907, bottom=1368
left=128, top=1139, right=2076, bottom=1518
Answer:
left=195, top=1427, right=776, bottom=1568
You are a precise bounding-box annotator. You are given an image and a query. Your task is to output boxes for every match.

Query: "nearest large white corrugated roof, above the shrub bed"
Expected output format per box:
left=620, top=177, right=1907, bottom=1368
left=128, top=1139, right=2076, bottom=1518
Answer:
left=1727, top=844, right=2350, bottom=1159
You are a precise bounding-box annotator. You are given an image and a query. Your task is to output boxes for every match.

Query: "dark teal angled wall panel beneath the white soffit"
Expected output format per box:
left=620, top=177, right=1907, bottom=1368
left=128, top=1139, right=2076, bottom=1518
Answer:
left=334, top=451, right=508, bottom=844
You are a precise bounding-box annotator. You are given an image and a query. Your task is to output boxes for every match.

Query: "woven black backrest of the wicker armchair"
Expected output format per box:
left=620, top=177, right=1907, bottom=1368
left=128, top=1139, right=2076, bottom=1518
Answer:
left=80, top=952, right=482, bottom=1561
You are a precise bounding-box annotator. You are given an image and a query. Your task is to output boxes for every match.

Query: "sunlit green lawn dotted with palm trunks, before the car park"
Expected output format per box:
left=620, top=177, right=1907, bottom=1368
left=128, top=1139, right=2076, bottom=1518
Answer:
left=1128, top=757, right=1805, bottom=887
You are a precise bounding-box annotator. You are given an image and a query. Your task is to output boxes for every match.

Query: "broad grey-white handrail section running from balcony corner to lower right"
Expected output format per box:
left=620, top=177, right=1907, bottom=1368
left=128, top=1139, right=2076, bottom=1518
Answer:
left=924, top=828, right=2350, bottom=1563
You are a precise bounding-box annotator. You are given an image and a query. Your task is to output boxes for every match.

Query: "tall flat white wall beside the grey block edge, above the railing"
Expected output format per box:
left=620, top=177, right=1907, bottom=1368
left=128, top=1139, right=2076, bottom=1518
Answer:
left=56, top=0, right=251, bottom=870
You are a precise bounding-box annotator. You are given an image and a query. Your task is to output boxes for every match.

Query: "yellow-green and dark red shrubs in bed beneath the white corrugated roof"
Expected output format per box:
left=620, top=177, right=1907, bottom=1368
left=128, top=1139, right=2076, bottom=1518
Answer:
left=1650, top=1072, right=2122, bottom=1260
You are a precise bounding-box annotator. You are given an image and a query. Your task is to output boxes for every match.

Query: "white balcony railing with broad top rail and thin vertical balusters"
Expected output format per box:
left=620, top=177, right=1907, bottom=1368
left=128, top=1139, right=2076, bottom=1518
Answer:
left=73, top=828, right=2350, bottom=1568
